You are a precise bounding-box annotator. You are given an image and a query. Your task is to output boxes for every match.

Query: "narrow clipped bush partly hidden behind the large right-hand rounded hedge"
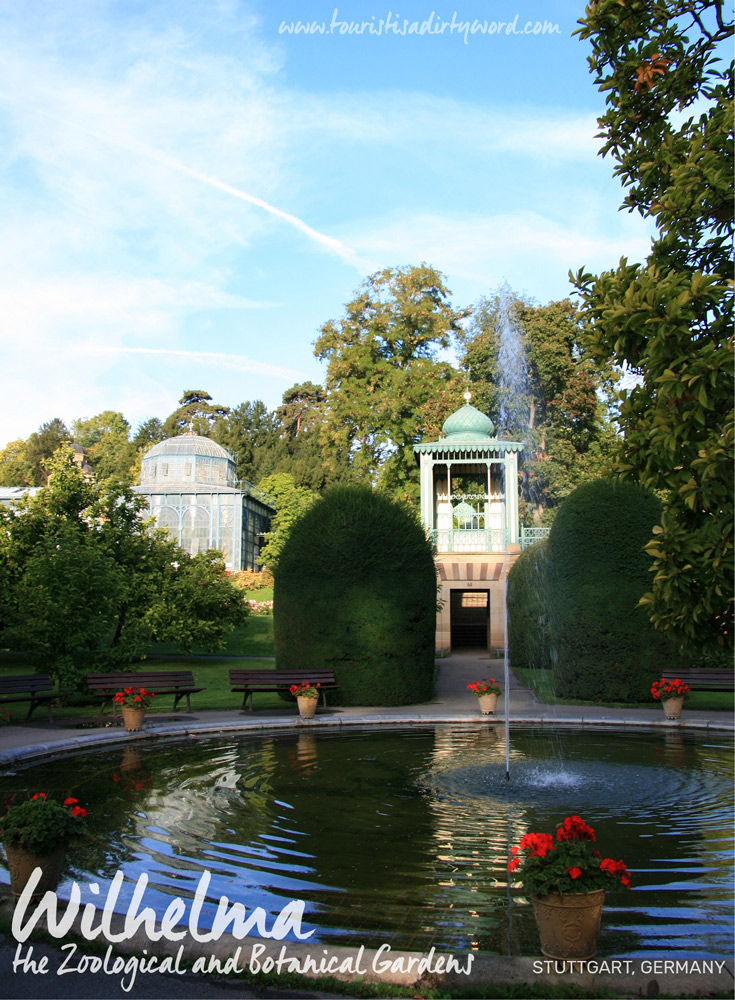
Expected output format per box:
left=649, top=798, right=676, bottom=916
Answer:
left=508, top=538, right=551, bottom=667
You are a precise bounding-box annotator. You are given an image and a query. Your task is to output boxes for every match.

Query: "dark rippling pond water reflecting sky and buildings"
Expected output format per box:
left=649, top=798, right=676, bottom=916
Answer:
left=0, top=722, right=733, bottom=957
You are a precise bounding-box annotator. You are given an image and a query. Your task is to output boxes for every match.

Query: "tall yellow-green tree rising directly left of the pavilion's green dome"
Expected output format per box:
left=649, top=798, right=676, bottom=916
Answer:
left=314, top=264, right=466, bottom=501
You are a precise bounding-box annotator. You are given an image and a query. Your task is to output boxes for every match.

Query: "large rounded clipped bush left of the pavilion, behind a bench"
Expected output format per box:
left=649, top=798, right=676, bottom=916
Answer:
left=274, top=486, right=436, bottom=705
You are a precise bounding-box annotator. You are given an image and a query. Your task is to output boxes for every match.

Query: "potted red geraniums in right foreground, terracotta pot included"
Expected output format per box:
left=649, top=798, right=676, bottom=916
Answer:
left=508, top=816, right=630, bottom=961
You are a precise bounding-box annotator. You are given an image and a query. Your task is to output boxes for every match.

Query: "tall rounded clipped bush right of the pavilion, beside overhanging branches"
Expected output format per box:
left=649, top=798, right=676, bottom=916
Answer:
left=547, top=480, right=677, bottom=702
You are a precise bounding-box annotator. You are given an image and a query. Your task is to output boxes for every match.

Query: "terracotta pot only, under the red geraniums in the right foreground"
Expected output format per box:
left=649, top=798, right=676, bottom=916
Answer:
left=531, top=889, right=605, bottom=961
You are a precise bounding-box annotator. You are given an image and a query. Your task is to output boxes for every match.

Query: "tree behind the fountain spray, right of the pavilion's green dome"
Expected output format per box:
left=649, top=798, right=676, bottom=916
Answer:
left=461, top=288, right=616, bottom=520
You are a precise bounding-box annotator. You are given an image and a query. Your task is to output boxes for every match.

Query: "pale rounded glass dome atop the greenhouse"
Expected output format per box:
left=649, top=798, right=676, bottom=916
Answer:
left=140, top=434, right=237, bottom=487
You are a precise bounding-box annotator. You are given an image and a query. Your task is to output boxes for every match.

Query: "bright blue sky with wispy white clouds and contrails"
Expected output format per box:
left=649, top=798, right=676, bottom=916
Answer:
left=0, top=0, right=651, bottom=447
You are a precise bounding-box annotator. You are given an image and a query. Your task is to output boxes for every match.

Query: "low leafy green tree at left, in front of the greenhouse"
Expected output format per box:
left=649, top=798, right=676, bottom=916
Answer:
left=0, top=449, right=247, bottom=690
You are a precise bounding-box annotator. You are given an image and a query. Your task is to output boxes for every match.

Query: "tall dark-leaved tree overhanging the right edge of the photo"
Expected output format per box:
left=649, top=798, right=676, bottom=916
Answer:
left=575, top=0, right=734, bottom=653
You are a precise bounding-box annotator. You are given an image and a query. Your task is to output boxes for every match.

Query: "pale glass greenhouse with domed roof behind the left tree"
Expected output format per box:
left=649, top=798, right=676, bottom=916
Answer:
left=134, top=434, right=274, bottom=572
